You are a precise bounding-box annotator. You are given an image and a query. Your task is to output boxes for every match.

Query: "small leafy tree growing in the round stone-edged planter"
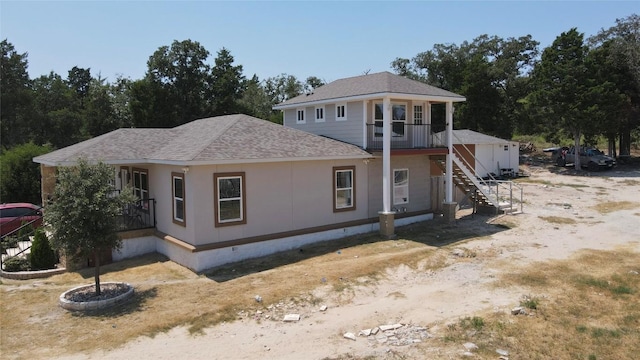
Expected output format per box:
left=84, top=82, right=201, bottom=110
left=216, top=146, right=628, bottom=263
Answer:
left=44, top=159, right=136, bottom=295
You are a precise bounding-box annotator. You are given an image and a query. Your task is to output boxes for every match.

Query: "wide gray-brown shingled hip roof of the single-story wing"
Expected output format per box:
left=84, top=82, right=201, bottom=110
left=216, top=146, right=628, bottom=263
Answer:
left=33, top=114, right=371, bottom=166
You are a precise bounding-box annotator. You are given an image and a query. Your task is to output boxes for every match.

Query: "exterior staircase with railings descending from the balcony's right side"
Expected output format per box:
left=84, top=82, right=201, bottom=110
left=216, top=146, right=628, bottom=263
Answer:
left=432, top=153, right=522, bottom=213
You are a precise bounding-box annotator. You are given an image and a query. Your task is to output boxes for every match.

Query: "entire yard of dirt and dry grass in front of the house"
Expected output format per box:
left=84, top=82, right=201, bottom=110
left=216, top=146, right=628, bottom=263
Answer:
left=0, top=164, right=640, bottom=360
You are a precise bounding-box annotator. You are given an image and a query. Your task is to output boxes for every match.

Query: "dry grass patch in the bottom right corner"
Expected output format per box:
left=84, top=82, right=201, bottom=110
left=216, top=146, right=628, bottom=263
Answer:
left=442, top=250, right=640, bottom=360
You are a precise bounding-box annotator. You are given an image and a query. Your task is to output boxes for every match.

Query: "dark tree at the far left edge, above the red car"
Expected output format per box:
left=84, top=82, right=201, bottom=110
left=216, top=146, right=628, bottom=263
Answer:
left=0, top=39, right=31, bottom=149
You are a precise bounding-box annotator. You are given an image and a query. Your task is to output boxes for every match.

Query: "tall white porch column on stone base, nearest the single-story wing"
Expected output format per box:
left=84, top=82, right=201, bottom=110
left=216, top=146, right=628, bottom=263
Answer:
left=378, top=97, right=395, bottom=238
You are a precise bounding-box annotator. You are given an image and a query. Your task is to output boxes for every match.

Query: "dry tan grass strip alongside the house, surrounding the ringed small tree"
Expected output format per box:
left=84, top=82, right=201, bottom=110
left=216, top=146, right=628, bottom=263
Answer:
left=0, top=215, right=504, bottom=359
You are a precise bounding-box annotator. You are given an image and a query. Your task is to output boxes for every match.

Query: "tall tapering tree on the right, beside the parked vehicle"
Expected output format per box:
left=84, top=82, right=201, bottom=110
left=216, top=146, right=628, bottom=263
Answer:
left=531, top=28, right=594, bottom=170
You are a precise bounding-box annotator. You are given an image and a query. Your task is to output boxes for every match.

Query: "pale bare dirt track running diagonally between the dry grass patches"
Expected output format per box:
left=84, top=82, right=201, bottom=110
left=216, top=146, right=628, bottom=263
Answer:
left=6, top=161, right=640, bottom=359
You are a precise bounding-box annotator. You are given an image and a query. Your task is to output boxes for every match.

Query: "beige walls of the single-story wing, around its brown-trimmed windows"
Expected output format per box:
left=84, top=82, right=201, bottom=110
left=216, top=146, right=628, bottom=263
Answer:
left=174, top=160, right=368, bottom=245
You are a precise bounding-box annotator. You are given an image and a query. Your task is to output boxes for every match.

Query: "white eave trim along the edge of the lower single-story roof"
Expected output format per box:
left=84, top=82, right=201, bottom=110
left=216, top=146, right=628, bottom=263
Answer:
left=33, top=154, right=375, bottom=166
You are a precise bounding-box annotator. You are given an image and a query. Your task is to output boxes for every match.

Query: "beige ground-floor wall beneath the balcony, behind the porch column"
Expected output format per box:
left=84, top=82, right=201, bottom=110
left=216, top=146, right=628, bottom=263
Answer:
left=369, top=155, right=431, bottom=217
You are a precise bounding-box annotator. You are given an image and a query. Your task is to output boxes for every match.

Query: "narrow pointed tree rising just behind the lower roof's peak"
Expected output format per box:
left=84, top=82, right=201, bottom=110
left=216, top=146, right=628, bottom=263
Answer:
left=211, top=48, right=246, bottom=115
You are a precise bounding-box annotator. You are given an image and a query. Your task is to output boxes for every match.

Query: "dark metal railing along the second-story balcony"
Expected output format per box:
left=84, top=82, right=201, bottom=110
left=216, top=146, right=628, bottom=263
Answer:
left=367, top=121, right=445, bottom=150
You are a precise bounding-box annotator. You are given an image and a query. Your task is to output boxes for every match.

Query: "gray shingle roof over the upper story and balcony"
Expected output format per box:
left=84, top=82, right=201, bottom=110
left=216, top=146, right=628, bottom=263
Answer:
left=276, top=71, right=464, bottom=108
